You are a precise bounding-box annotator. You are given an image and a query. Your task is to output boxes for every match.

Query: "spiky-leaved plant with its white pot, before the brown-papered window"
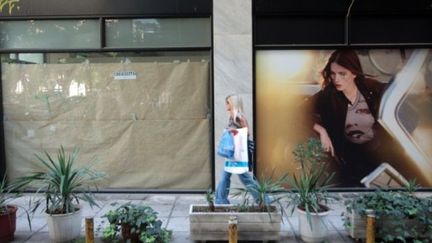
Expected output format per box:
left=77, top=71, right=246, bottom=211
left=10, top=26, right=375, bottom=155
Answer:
left=17, top=146, right=103, bottom=242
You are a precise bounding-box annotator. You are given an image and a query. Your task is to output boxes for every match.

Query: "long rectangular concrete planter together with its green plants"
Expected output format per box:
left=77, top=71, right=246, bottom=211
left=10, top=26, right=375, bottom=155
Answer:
left=189, top=173, right=285, bottom=241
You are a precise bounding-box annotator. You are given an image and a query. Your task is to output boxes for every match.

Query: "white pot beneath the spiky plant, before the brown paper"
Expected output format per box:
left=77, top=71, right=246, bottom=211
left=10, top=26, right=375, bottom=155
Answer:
left=46, top=210, right=82, bottom=242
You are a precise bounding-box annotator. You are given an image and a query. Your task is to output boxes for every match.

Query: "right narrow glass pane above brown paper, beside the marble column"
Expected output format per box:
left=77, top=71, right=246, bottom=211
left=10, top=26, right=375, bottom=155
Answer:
left=105, top=18, right=211, bottom=47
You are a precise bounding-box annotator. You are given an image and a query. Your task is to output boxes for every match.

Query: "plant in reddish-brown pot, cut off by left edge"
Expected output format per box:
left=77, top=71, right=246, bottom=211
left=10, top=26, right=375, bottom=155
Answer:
left=0, top=174, right=31, bottom=242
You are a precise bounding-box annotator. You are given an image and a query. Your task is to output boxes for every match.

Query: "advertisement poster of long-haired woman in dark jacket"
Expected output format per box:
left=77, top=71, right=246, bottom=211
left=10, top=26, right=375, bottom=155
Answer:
left=255, top=48, right=432, bottom=188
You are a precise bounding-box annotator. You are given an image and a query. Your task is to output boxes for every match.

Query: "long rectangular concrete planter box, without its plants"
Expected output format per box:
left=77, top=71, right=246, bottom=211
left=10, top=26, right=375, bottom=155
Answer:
left=189, top=204, right=282, bottom=241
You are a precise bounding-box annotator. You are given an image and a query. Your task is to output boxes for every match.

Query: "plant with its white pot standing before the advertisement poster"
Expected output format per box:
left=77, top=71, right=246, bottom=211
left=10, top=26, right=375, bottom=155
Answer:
left=288, top=138, right=337, bottom=242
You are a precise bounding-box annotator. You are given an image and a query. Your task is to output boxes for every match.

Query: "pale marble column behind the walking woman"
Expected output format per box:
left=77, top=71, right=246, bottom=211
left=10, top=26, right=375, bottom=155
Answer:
left=213, top=0, right=253, bottom=188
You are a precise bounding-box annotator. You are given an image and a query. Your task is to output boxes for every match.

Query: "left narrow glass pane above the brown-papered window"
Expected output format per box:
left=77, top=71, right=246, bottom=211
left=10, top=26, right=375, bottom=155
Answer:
left=0, top=20, right=100, bottom=49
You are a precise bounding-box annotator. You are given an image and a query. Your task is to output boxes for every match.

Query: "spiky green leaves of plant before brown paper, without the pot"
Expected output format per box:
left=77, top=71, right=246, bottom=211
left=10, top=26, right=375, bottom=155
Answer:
left=17, top=146, right=104, bottom=214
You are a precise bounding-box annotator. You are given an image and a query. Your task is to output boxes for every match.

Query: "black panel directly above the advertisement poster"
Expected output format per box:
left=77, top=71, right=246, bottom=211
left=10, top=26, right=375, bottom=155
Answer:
left=253, top=0, right=432, bottom=47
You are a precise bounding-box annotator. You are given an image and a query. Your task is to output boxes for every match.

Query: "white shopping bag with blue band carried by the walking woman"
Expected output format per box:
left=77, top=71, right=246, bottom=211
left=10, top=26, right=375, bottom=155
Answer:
left=225, top=128, right=249, bottom=174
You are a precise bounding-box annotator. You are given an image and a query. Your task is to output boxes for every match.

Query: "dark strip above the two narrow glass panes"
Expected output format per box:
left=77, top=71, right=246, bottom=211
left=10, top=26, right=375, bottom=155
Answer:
left=0, top=0, right=212, bottom=18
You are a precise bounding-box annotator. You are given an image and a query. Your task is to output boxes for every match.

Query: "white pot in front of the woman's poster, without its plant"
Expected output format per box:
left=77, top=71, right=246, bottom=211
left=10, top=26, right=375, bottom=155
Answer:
left=297, top=208, right=330, bottom=242
